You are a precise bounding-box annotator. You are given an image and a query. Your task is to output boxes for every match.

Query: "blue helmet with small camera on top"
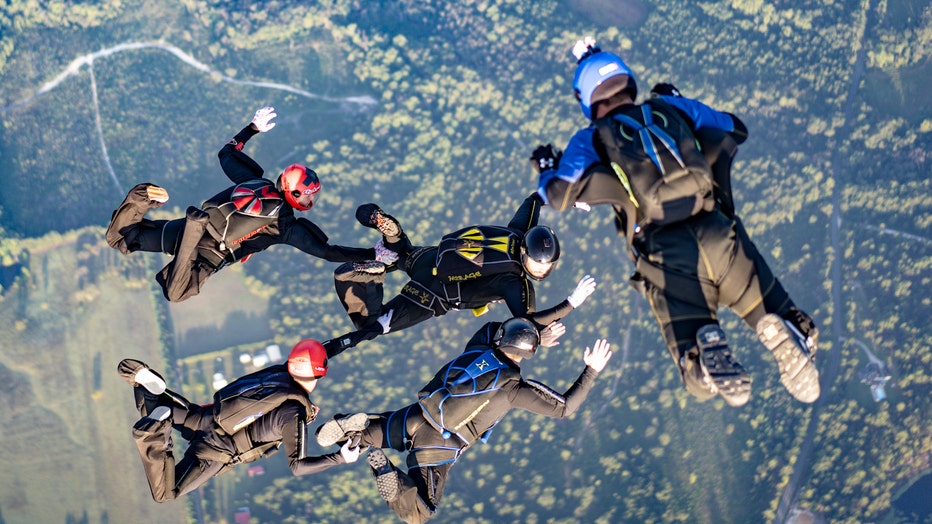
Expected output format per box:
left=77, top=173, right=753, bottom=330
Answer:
left=573, top=42, right=637, bottom=119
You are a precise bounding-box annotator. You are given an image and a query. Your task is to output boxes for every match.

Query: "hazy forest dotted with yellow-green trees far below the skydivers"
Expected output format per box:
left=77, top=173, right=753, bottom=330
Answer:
left=0, top=0, right=932, bottom=523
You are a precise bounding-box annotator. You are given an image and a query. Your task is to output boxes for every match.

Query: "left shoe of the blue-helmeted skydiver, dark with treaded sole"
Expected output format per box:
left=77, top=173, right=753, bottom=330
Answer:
left=696, top=324, right=751, bottom=407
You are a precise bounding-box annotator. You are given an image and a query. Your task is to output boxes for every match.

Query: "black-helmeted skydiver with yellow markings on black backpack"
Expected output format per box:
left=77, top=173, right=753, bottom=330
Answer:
left=324, top=193, right=595, bottom=357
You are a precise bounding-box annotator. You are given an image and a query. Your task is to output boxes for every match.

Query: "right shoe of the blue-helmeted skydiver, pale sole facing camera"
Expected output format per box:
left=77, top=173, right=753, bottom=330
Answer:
left=757, top=313, right=821, bottom=404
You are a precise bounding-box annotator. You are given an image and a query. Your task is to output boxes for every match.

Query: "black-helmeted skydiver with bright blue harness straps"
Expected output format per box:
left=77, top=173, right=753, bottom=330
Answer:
left=317, top=318, right=612, bottom=523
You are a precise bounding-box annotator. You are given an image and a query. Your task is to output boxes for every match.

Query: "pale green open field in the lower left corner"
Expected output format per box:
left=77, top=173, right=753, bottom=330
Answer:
left=0, top=230, right=188, bottom=524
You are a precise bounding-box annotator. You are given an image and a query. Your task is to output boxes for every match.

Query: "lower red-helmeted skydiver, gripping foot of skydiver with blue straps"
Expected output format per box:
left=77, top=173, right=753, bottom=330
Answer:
left=117, top=340, right=361, bottom=502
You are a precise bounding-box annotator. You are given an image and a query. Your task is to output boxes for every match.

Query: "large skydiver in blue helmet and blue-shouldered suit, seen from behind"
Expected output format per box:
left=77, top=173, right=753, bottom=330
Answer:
left=531, top=37, right=820, bottom=406
